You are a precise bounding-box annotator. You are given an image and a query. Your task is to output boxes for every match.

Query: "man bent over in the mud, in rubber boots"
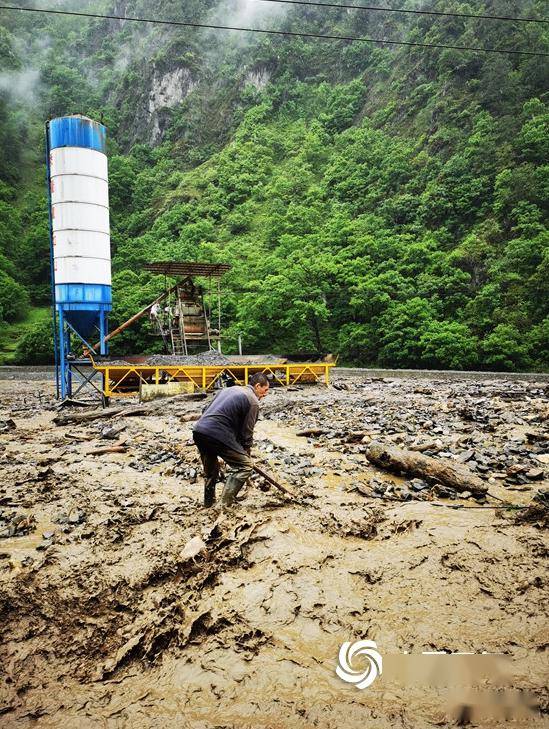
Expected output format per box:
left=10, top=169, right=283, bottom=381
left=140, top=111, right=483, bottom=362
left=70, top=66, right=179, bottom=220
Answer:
left=193, top=372, right=269, bottom=506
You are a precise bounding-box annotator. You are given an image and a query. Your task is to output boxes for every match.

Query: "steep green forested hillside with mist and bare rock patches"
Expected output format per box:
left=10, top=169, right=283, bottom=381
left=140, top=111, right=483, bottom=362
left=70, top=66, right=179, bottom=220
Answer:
left=0, top=0, right=549, bottom=370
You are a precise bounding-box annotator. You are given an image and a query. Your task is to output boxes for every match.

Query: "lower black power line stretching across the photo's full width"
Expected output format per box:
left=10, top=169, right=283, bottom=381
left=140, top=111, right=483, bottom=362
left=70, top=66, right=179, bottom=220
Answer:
left=0, top=5, right=549, bottom=57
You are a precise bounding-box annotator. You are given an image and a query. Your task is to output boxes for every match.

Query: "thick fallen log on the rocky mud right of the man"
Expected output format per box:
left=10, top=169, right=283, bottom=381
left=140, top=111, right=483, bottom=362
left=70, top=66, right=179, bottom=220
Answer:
left=366, top=441, right=488, bottom=496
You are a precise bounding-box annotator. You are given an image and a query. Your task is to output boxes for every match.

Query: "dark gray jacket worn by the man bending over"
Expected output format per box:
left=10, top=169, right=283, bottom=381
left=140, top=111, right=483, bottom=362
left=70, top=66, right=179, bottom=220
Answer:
left=193, top=385, right=259, bottom=453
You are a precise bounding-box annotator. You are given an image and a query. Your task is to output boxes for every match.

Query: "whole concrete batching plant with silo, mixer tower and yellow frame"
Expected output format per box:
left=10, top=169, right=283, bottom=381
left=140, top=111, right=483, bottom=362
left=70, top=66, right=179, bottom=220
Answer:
left=42, top=115, right=332, bottom=405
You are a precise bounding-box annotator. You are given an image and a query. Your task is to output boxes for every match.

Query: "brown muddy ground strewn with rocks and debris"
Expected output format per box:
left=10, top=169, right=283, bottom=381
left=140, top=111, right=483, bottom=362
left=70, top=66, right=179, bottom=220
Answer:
left=0, top=377, right=549, bottom=729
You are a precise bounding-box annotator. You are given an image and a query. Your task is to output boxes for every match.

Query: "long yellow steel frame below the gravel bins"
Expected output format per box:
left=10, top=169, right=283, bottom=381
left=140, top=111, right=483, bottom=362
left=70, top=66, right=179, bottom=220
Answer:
left=94, top=362, right=334, bottom=397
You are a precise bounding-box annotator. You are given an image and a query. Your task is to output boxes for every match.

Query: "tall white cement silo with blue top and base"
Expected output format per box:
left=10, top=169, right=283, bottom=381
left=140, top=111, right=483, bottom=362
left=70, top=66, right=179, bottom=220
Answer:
left=46, top=116, right=112, bottom=399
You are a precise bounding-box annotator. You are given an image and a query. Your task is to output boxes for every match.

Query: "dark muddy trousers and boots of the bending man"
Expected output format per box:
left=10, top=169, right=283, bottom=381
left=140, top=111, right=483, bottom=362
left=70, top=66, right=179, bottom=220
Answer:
left=193, top=432, right=253, bottom=506
